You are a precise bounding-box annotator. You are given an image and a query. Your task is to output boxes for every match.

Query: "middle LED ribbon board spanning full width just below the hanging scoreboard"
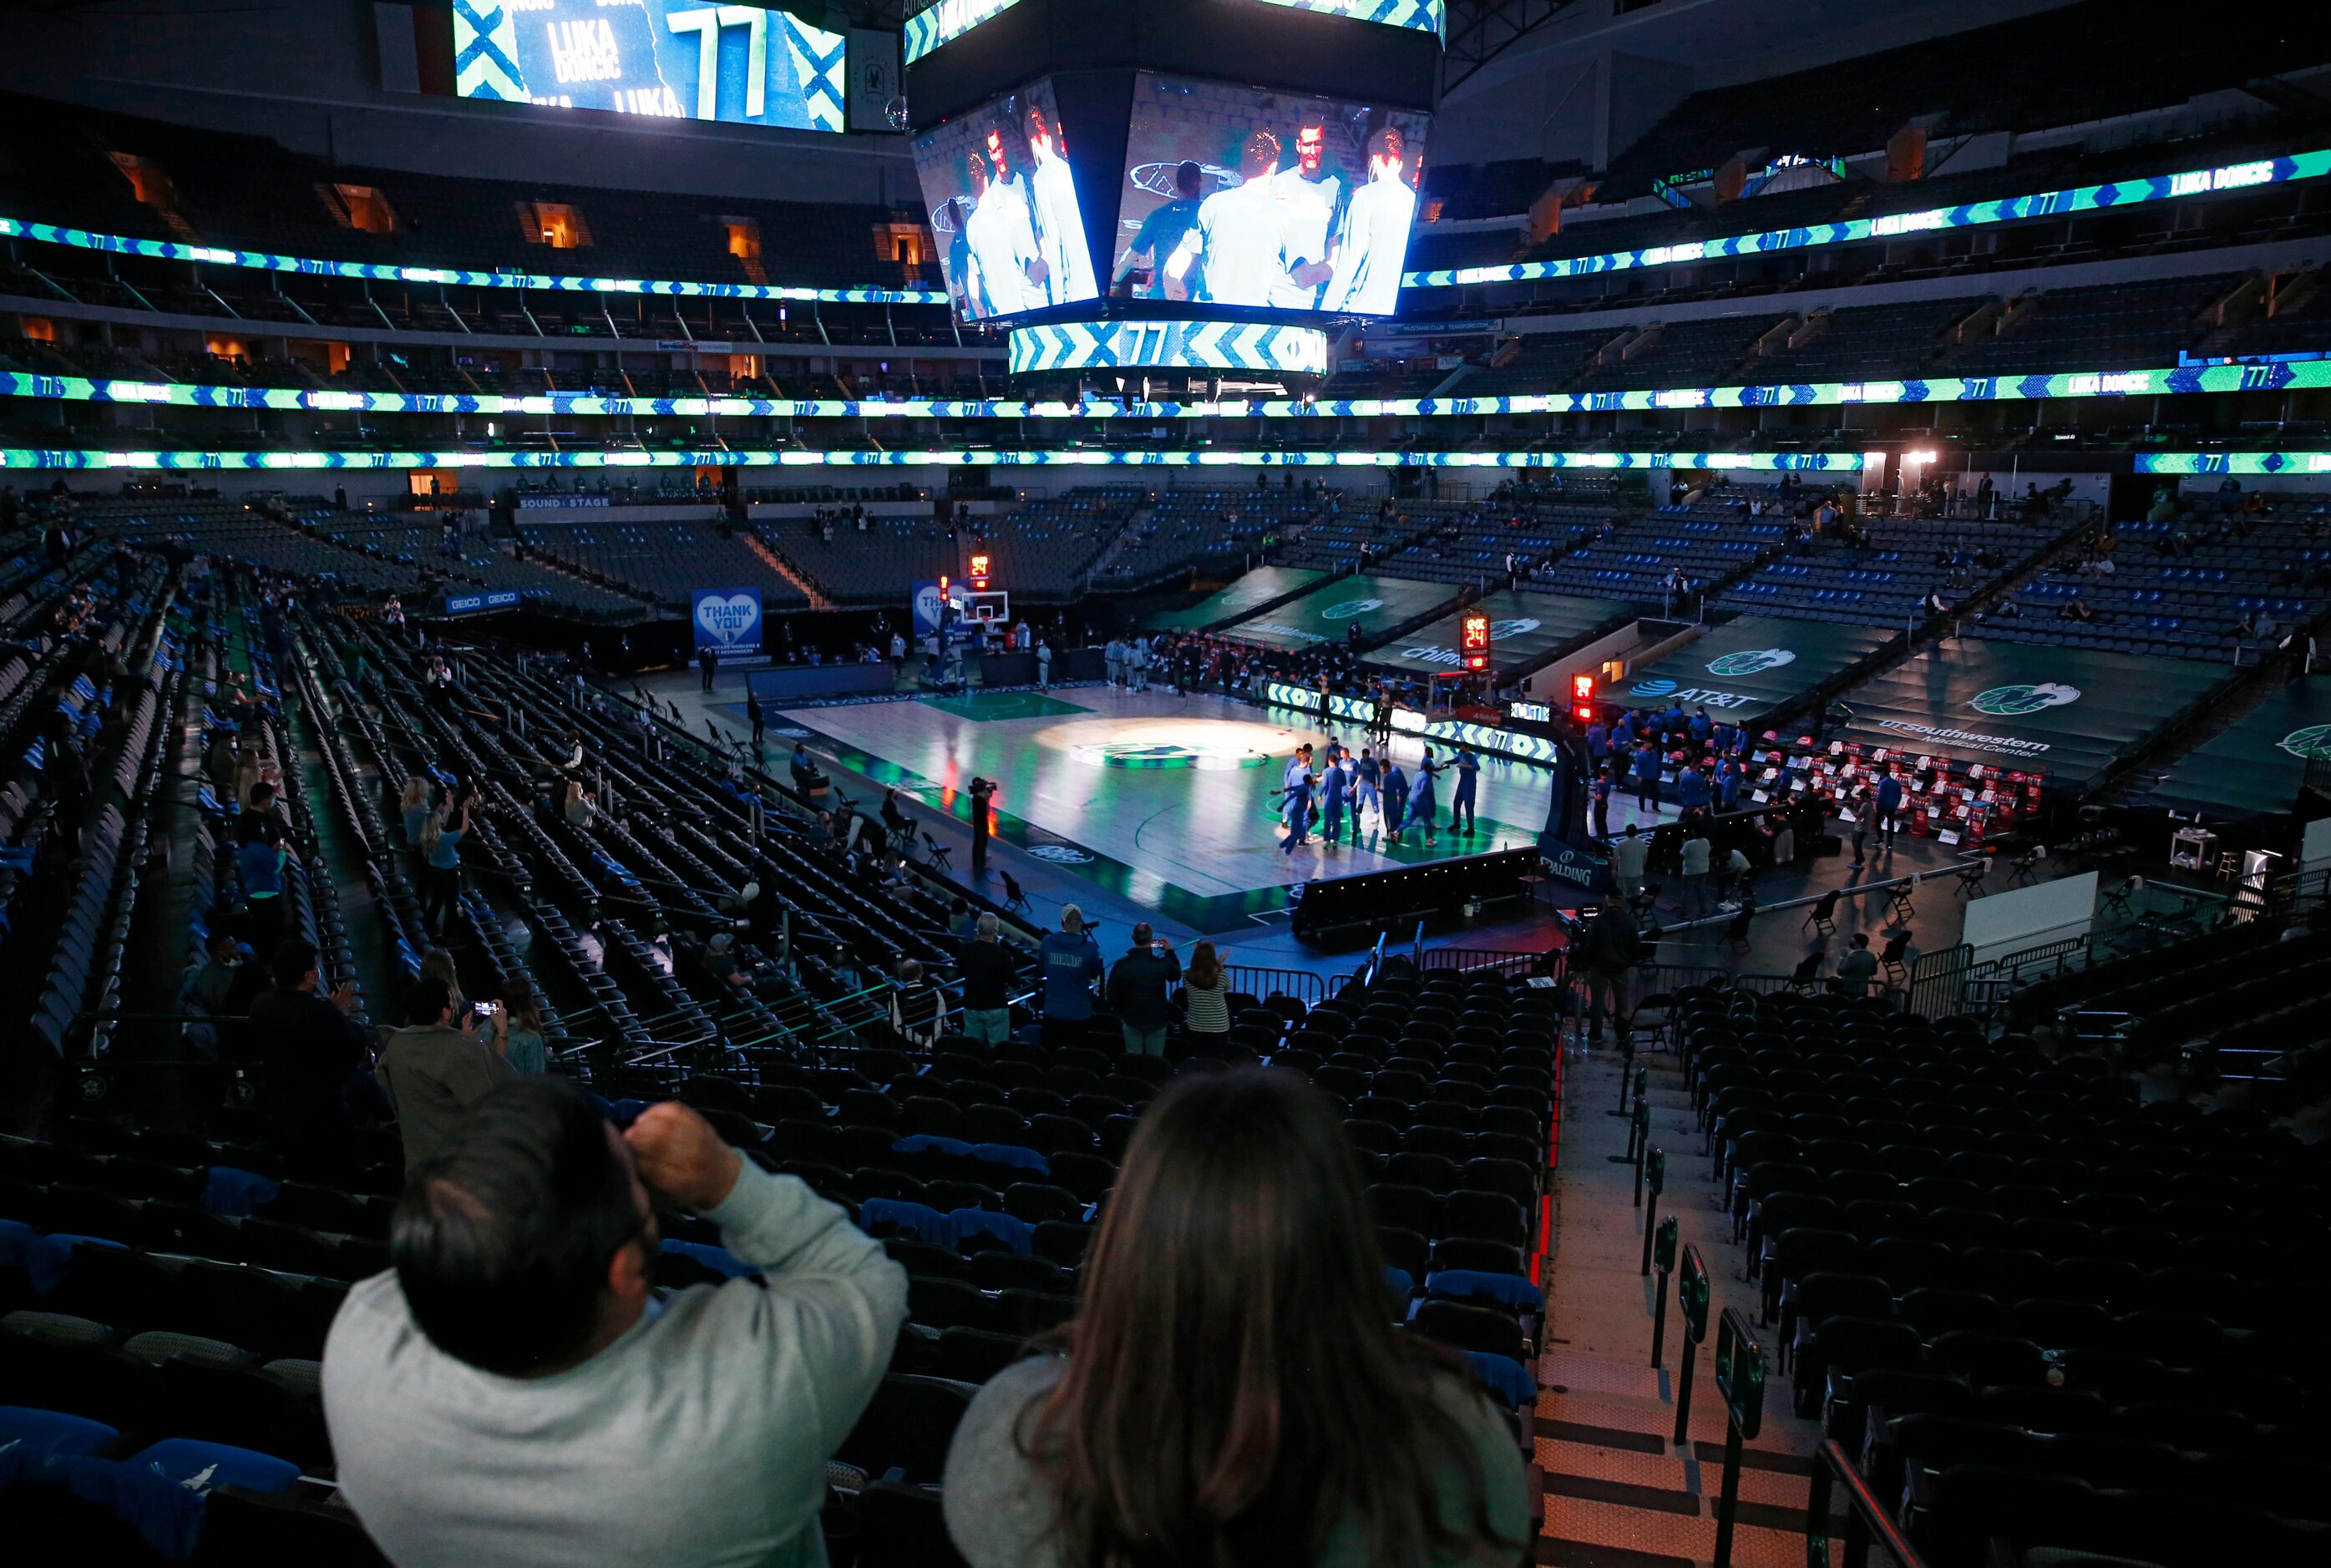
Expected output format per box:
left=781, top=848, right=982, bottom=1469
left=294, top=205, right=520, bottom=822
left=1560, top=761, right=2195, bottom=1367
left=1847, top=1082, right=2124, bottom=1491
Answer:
left=0, top=356, right=2331, bottom=419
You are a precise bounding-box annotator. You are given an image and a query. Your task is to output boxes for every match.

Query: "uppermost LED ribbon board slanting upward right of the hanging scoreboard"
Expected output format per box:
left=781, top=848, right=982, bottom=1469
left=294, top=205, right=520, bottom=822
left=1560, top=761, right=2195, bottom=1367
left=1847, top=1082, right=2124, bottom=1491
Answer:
left=1401, top=149, right=2331, bottom=289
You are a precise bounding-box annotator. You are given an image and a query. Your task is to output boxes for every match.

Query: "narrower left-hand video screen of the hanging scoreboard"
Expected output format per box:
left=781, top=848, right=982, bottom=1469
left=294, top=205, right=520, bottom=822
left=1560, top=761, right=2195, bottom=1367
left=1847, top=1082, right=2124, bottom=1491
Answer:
left=914, top=82, right=1100, bottom=321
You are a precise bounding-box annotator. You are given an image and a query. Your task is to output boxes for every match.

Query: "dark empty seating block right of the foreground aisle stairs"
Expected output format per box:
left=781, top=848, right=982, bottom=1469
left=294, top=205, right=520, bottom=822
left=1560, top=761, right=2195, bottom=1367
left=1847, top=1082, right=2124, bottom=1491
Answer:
left=1676, top=988, right=2331, bottom=1568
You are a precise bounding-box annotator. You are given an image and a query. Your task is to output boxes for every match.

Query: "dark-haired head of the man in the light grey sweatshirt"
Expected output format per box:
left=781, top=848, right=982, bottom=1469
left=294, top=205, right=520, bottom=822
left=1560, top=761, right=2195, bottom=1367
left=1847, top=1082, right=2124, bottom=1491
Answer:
left=389, top=1079, right=648, bottom=1377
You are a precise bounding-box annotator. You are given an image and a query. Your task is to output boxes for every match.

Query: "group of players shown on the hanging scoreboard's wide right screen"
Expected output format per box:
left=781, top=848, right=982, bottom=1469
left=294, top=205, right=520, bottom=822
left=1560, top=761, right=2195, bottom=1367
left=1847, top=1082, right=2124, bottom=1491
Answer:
left=1112, top=119, right=1417, bottom=315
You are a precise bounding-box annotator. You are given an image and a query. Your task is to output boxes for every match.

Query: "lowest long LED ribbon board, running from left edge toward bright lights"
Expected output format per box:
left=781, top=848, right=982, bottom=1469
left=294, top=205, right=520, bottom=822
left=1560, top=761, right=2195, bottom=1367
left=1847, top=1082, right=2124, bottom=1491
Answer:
left=0, top=448, right=1862, bottom=473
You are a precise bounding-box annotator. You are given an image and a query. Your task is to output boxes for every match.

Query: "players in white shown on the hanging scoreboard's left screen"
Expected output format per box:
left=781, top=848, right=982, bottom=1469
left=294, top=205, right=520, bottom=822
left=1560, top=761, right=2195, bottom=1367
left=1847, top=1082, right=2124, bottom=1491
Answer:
left=937, top=103, right=1098, bottom=319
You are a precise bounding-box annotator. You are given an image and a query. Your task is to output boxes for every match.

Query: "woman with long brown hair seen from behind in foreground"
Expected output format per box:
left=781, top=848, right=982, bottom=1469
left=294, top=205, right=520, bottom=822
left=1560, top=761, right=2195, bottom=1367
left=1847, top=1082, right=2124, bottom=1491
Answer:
left=944, top=1070, right=1529, bottom=1568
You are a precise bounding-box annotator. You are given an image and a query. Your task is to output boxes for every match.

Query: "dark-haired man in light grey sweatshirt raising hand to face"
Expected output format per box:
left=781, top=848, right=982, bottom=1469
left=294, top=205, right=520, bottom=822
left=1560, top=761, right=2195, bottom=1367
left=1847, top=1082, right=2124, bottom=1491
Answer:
left=324, top=1079, right=907, bottom=1568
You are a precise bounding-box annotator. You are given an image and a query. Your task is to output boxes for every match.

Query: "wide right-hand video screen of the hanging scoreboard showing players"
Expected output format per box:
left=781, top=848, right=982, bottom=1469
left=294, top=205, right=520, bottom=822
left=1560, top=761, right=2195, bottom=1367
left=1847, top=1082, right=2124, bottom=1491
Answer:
left=1110, top=73, right=1432, bottom=315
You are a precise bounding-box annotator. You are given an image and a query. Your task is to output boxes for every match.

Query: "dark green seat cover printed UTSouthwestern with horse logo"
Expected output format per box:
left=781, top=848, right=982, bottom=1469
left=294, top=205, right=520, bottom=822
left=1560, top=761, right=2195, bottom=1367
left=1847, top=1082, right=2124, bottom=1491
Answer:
left=1832, top=636, right=2233, bottom=795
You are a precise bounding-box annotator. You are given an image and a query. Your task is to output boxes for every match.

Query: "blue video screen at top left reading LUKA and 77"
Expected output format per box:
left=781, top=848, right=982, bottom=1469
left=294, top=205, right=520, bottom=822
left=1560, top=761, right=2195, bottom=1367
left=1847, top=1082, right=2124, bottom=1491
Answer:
left=452, top=0, right=849, bottom=130
